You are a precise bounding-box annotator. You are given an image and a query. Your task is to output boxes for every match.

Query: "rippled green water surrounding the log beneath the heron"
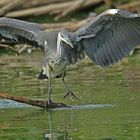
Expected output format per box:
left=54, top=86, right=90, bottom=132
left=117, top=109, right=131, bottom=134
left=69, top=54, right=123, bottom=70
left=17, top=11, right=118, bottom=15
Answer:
left=0, top=52, right=140, bottom=140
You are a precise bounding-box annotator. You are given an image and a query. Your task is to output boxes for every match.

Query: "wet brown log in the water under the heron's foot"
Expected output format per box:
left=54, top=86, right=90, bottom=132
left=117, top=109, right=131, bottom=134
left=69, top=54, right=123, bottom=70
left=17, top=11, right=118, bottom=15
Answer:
left=0, top=93, right=70, bottom=109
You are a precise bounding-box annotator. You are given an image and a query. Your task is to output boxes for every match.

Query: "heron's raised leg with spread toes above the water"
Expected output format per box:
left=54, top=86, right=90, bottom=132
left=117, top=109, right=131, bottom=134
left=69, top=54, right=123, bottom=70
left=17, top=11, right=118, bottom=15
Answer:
left=62, top=72, right=77, bottom=99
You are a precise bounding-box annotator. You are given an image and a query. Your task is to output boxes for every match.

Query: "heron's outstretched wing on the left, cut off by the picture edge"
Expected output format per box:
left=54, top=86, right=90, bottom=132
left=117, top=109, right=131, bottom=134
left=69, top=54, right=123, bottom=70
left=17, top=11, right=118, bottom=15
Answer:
left=0, top=17, right=43, bottom=46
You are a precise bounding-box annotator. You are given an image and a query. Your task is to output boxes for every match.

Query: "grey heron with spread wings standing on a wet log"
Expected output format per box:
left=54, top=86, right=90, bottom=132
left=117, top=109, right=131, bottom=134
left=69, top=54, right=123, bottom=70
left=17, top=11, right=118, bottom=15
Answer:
left=0, top=9, right=140, bottom=102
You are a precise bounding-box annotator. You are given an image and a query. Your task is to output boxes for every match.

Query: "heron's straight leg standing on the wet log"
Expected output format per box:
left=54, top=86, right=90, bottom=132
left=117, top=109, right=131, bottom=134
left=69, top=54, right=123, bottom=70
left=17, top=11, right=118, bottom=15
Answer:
left=48, top=71, right=52, bottom=104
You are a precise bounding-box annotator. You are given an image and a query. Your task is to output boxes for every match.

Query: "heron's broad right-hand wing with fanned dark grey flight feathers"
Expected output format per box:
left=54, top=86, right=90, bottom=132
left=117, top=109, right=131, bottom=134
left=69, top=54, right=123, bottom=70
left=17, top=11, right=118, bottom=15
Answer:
left=73, top=9, right=140, bottom=67
